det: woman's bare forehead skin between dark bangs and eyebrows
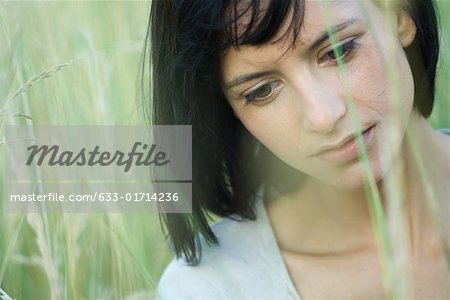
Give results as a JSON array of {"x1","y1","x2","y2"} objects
[{"x1": 220, "y1": 0, "x2": 396, "y2": 84}]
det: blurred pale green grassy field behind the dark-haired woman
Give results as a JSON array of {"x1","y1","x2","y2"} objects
[{"x1": 0, "y1": 0, "x2": 450, "y2": 299}]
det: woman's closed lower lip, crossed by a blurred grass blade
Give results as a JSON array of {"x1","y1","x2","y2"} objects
[{"x1": 316, "y1": 125, "x2": 376, "y2": 163}]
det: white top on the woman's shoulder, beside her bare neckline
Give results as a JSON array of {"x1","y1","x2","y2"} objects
[{"x1": 156, "y1": 193, "x2": 300, "y2": 300}]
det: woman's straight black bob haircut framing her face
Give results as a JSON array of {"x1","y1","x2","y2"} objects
[{"x1": 147, "y1": 0, "x2": 439, "y2": 265}]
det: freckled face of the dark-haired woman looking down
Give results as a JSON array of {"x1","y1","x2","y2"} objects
[{"x1": 221, "y1": 0, "x2": 415, "y2": 189}]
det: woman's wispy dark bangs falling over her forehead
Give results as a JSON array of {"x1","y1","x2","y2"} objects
[{"x1": 222, "y1": 0, "x2": 305, "y2": 49}]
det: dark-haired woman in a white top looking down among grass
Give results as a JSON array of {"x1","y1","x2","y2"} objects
[{"x1": 149, "y1": 0, "x2": 450, "y2": 299}]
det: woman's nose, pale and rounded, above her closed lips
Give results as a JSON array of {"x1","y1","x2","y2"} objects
[{"x1": 300, "y1": 75, "x2": 347, "y2": 134}]
